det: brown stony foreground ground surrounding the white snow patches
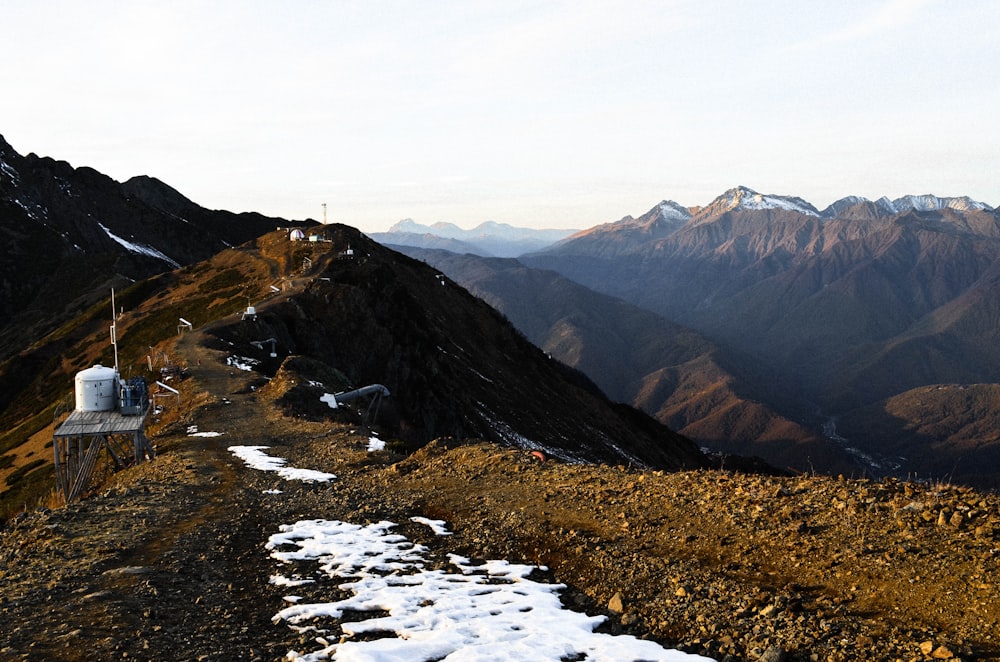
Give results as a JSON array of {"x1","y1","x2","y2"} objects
[{"x1": 0, "y1": 334, "x2": 1000, "y2": 661}]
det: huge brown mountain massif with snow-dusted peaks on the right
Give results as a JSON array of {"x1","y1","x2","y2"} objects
[{"x1": 522, "y1": 189, "x2": 1000, "y2": 482}]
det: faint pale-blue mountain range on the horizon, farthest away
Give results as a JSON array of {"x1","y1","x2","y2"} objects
[{"x1": 369, "y1": 219, "x2": 576, "y2": 257}]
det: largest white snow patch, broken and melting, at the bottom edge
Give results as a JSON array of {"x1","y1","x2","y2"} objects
[{"x1": 266, "y1": 519, "x2": 709, "y2": 662}]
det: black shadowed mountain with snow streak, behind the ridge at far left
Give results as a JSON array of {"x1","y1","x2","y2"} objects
[{"x1": 0, "y1": 137, "x2": 310, "y2": 358}]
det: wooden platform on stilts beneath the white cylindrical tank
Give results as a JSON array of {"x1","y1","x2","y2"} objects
[{"x1": 53, "y1": 408, "x2": 155, "y2": 503}]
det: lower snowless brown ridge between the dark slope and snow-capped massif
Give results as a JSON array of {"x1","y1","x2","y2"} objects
[{"x1": 390, "y1": 246, "x2": 862, "y2": 473}]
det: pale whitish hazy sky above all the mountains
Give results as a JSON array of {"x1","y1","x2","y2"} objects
[{"x1": 0, "y1": 0, "x2": 1000, "y2": 231}]
